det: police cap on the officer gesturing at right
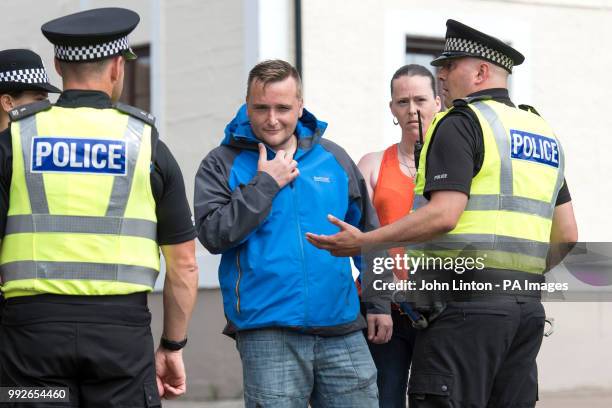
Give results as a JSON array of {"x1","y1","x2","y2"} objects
[{"x1": 431, "y1": 19, "x2": 525, "y2": 73}]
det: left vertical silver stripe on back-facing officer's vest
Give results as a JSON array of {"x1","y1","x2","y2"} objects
[{"x1": 19, "y1": 115, "x2": 49, "y2": 214}]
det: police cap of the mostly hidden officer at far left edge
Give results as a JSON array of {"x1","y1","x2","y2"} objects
[{"x1": 0, "y1": 49, "x2": 61, "y2": 93}]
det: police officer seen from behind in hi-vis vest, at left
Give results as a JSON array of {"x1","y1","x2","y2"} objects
[{"x1": 0, "y1": 8, "x2": 198, "y2": 407}]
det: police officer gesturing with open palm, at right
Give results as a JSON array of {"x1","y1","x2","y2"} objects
[{"x1": 308, "y1": 20, "x2": 578, "y2": 408}]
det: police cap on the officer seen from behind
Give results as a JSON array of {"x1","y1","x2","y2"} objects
[{"x1": 41, "y1": 7, "x2": 140, "y2": 62}]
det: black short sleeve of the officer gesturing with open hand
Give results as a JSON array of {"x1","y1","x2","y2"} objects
[{"x1": 423, "y1": 111, "x2": 483, "y2": 200}]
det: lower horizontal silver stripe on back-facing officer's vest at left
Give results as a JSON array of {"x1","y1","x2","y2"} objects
[{"x1": 2, "y1": 261, "x2": 157, "y2": 287}]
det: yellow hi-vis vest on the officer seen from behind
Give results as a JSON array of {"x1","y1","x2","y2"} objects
[{"x1": 0, "y1": 103, "x2": 159, "y2": 298}]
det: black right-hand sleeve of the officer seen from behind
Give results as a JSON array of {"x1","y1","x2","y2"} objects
[{"x1": 151, "y1": 140, "x2": 196, "y2": 245}]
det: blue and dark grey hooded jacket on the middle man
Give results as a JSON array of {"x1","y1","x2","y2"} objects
[{"x1": 194, "y1": 106, "x2": 388, "y2": 335}]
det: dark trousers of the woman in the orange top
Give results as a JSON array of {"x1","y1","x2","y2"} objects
[{"x1": 368, "y1": 310, "x2": 417, "y2": 408}]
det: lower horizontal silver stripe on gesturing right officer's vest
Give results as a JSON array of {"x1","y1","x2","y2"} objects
[{"x1": 408, "y1": 234, "x2": 548, "y2": 258}]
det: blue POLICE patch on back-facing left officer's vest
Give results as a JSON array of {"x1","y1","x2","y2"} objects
[{"x1": 30, "y1": 137, "x2": 127, "y2": 175}]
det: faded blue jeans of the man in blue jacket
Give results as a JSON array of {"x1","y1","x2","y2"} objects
[{"x1": 236, "y1": 328, "x2": 378, "y2": 408}]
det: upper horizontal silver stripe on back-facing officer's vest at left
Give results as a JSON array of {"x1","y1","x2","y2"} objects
[{"x1": 5, "y1": 214, "x2": 157, "y2": 241}]
